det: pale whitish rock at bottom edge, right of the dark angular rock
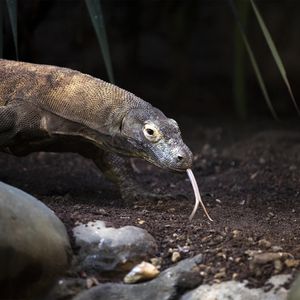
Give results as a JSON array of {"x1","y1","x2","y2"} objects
[{"x1": 180, "y1": 275, "x2": 290, "y2": 300}]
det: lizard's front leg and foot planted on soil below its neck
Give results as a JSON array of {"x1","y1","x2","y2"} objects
[{"x1": 92, "y1": 150, "x2": 171, "y2": 201}]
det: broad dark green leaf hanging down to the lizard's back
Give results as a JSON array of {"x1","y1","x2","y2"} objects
[{"x1": 85, "y1": 0, "x2": 114, "y2": 83}]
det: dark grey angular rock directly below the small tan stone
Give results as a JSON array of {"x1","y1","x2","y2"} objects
[{"x1": 74, "y1": 254, "x2": 202, "y2": 300}]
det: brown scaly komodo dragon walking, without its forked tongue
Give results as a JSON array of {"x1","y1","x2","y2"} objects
[{"x1": 0, "y1": 59, "x2": 192, "y2": 199}]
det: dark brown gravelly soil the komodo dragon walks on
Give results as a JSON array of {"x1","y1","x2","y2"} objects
[{"x1": 0, "y1": 119, "x2": 300, "y2": 288}]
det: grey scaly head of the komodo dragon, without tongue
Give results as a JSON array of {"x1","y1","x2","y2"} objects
[{"x1": 120, "y1": 106, "x2": 193, "y2": 171}]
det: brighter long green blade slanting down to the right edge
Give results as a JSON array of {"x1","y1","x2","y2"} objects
[{"x1": 250, "y1": 0, "x2": 300, "y2": 116}]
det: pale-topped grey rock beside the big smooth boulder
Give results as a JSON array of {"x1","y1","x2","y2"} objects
[{"x1": 73, "y1": 221, "x2": 157, "y2": 274}]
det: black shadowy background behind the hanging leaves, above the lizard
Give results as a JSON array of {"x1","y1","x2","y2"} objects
[{"x1": 2, "y1": 0, "x2": 300, "y2": 118}]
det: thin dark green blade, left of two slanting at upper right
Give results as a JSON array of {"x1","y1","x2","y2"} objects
[{"x1": 228, "y1": 0, "x2": 278, "y2": 120}]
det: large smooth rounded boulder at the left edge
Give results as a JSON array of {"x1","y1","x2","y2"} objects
[{"x1": 0, "y1": 182, "x2": 71, "y2": 299}]
